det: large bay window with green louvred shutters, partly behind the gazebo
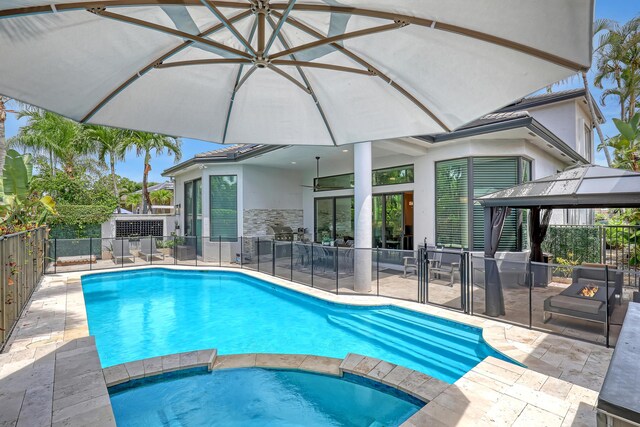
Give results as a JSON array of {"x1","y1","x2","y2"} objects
[{"x1": 436, "y1": 157, "x2": 532, "y2": 251}]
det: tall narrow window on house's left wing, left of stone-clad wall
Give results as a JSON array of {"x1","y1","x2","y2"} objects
[{"x1": 209, "y1": 175, "x2": 238, "y2": 242}]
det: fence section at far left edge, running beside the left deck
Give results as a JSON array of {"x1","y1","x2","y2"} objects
[{"x1": 0, "y1": 227, "x2": 47, "y2": 351}]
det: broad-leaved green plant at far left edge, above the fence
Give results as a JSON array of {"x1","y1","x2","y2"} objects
[{"x1": 0, "y1": 150, "x2": 56, "y2": 233}]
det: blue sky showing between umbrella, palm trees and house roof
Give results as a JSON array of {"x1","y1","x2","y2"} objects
[{"x1": 6, "y1": 0, "x2": 640, "y2": 182}]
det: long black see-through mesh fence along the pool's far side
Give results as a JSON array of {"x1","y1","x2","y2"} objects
[{"x1": 45, "y1": 236, "x2": 624, "y2": 345}]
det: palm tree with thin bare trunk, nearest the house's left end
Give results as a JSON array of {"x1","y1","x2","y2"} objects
[{"x1": 127, "y1": 131, "x2": 182, "y2": 213}]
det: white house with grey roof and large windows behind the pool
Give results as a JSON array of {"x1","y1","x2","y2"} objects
[{"x1": 163, "y1": 90, "x2": 602, "y2": 258}]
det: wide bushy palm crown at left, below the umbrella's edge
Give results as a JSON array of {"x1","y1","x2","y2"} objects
[{"x1": 15, "y1": 108, "x2": 95, "y2": 177}]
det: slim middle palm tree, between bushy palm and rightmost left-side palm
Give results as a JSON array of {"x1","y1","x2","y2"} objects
[{"x1": 86, "y1": 126, "x2": 131, "y2": 213}]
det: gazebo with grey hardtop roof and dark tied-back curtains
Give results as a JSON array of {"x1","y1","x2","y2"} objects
[{"x1": 476, "y1": 165, "x2": 640, "y2": 316}]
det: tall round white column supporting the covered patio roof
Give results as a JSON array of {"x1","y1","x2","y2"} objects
[{"x1": 353, "y1": 142, "x2": 373, "y2": 292}]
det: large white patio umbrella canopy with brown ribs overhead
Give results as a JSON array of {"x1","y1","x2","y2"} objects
[{"x1": 0, "y1": 0, "x2": 593, "y2": 145}]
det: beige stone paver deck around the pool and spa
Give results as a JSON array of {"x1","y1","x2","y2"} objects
[{"x1": 0, "y1": 266, "x2": 612, "y2": 426}]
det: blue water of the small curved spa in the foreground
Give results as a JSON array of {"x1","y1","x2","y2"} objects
[{"x1": 109, "y1": 368, "x2": 423, "y2": 427}]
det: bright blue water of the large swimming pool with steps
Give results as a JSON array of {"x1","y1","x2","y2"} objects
[{"x1": 82, "y1": 268, "x2": 508, "y2": 383}]
